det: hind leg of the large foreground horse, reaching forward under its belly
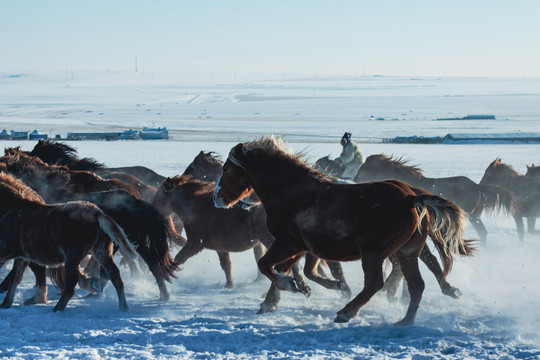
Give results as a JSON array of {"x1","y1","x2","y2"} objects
[{"x1": 334, "y1": 254, "x2": 384, "y2": 323}]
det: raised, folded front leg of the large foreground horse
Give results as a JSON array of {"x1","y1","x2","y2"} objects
[{"x1": 259, "y1": 240, "x2": 310, "y2": 296}]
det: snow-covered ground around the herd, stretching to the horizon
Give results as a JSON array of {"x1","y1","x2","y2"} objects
[{"x1": 0, "y1": 72, "x2": 540, "y2": 359}]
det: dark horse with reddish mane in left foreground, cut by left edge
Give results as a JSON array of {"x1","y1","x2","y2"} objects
[{"x1": 0, "y1": 173, "x2": 135, "y2": 311}]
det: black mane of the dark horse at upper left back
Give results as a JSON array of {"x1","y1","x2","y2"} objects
[{"x1": 29, "y1": 139, "x2": 105, "y2": 171}]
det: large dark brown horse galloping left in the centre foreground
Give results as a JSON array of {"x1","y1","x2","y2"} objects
[{"x1": 214, "y1": 136, "x2": 473, "y2": 325}]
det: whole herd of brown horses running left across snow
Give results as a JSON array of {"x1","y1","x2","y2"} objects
[{"x1": 0, "y1": 136, "x2": 540, "y2": 325}]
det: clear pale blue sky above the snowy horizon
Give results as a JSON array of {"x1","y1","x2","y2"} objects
[{"x1": 0, "y1": 0, "x2": 540, "y2": 76}]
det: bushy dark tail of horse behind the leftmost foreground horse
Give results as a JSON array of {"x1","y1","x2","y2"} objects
[{"x1": 137, "y1": 216, "x2": 178, "y2": 282}]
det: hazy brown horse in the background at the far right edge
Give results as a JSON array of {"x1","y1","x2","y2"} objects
[{"x1": 480, "y1": 158, "x2": 540, "y2": 241}]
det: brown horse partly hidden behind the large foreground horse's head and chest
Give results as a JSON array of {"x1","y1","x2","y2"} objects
[{"x1": 153, "y1": 175, "x2": 273, "y2": 288}]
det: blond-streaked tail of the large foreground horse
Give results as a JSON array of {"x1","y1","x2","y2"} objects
[{"x1": 413, "y1": 195, "x2": 475, "y2": 279}]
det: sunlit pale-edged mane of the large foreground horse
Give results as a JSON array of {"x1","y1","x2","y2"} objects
[{"x1": 229, "y1": 135, "x2": 335, "y2": 181}]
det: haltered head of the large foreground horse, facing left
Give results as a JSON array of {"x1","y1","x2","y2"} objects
[{"x1": 214, "y1": 144, "x2": 253, "y2": 208}]
